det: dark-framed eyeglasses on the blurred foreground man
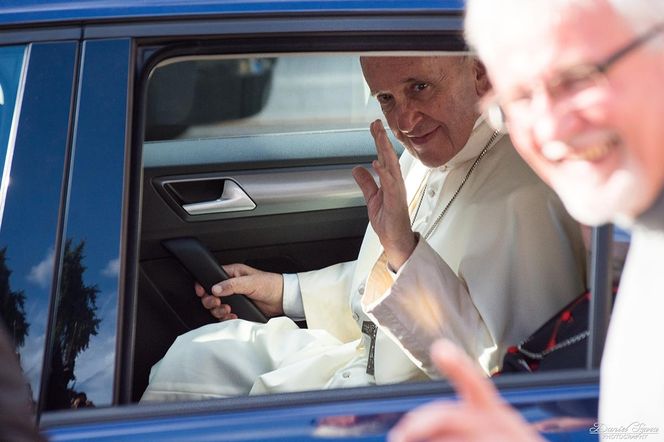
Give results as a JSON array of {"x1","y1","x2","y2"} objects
[{"x1": 483, "y1": 23, "x2": 664, "y2": 132}]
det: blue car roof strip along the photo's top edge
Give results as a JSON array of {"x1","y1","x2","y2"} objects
[{"x1": 0, "y1": 0, "x2": 464, "y2": 26}]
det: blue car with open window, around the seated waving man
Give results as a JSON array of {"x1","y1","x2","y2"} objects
[{"x1": 0, "y1": 0, "x2": 616, "y2": 441}]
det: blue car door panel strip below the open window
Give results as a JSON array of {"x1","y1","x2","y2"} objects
[{"x1": 47, "y1": 383, "x2": 598, "y2": 442}]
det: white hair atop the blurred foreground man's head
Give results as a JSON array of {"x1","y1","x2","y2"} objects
[{"x1": 465, "y1": 0, "x2": 664, "y2": 64}]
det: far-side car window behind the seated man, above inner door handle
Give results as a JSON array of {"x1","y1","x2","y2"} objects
[{"x1": 146, "y1": 55, "x2": 380, "y2": 140}]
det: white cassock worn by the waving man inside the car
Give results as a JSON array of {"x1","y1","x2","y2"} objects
[{"x1": 142, "y1": 121, "x2": 585, "y2": 401}]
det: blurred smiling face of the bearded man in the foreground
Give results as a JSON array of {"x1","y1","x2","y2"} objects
[{"x1": 485, "y1": 2, "x2": 664, "y2": 224}]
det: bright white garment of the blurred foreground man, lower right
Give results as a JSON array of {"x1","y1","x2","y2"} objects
[{"x1": 596, "y1": 192, "x2": 664, "y2": 434}]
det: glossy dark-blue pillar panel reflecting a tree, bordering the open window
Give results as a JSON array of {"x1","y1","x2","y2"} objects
[{"x1": 45, "y1": 40, "x2": 130, "y2": 410}]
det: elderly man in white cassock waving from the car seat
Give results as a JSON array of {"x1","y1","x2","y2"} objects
[{"x1": 142, "y1": 56, "x2": 585, "y2": 401}]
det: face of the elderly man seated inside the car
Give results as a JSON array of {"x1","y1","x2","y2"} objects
[{"x1": 361, "y1": 57, "x2": 488, "y2": 167}]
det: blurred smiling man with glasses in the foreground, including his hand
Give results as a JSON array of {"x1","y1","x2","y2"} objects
[{"x1": 391, "y1": 0, "x2": 664, "y2": 441}]
